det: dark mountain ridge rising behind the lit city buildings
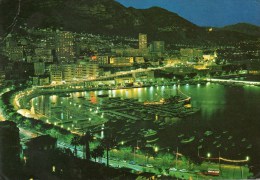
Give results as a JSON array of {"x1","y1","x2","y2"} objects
[{"x1": 0, "y1": 0, "x2": 256, "y2": 44}]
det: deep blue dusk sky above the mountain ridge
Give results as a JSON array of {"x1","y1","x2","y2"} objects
[{"x1": 116, "y1": 0, "x2": 260, "y2": 27}]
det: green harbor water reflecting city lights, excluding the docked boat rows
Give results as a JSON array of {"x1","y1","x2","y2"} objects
[{"x1": 31, "y1": 83, "x2": 260, "y2": 170}]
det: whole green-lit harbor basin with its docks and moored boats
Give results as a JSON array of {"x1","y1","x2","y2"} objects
[{"x1": 28, "y1": 83, "x2": 260, "y2": 167}]
